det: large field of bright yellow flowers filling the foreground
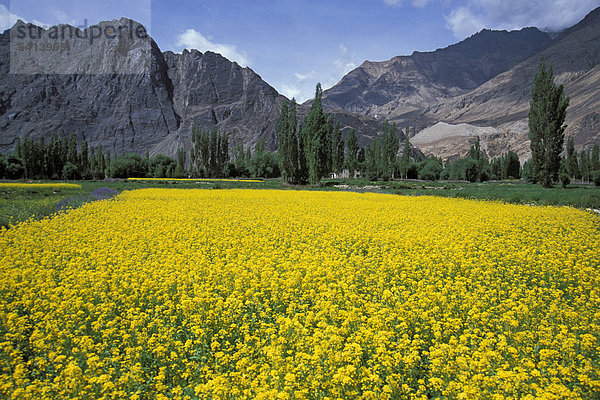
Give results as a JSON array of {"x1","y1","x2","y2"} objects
[{"x1": 0, "y1": 189, "x2": 600, "y2": 399}]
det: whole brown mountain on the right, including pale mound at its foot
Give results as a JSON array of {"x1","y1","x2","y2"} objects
[{"x1": 324, "y1": 8, "x2": 600, "y2": 161}]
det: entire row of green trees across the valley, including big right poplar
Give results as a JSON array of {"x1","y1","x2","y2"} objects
[{"x1": 0, "y1": 74, "x2": 600, "y2": 187}]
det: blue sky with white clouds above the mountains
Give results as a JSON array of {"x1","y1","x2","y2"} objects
[{"x1": 0, "y1": 0, "x2": 600, "y2": 101}]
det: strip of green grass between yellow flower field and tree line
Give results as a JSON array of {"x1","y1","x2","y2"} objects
[{"x1": 0, "y1": 179, "x2": 600, "y2": 227}]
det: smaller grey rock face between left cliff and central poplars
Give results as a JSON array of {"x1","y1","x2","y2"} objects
[{"x1": 153, "y1": 50, "x2": 285, "y2": 154}]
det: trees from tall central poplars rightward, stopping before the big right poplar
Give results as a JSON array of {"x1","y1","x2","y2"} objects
[{"x1": 277, "y1": 85, "x2": 540, "y2": 184}]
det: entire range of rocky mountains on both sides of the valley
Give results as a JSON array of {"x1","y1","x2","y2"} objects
[{"x1": 0, "y1": 9, "x2": 600, "y2": 161}]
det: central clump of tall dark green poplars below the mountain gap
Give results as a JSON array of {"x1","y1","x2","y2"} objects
[{"x1": 277, "y1": 84, "x2": 411, "y2": 185}]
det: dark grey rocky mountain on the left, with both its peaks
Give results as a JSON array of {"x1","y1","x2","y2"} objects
[{"x1": 0, "y1": 18, "x2": 380, "y2": 155}]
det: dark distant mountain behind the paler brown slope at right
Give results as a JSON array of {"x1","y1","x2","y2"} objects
[{"x1": 323, "y1": 28, "x2": 551, "y2": 115}]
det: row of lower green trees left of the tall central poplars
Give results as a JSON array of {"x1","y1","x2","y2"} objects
[{"x1": 0, "y1": 127, "x2": 280, "y2": 180}]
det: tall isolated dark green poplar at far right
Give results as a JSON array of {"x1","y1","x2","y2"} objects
[{"x1": 529, "y1": 59, "x2": 569, "y2": 187}]
